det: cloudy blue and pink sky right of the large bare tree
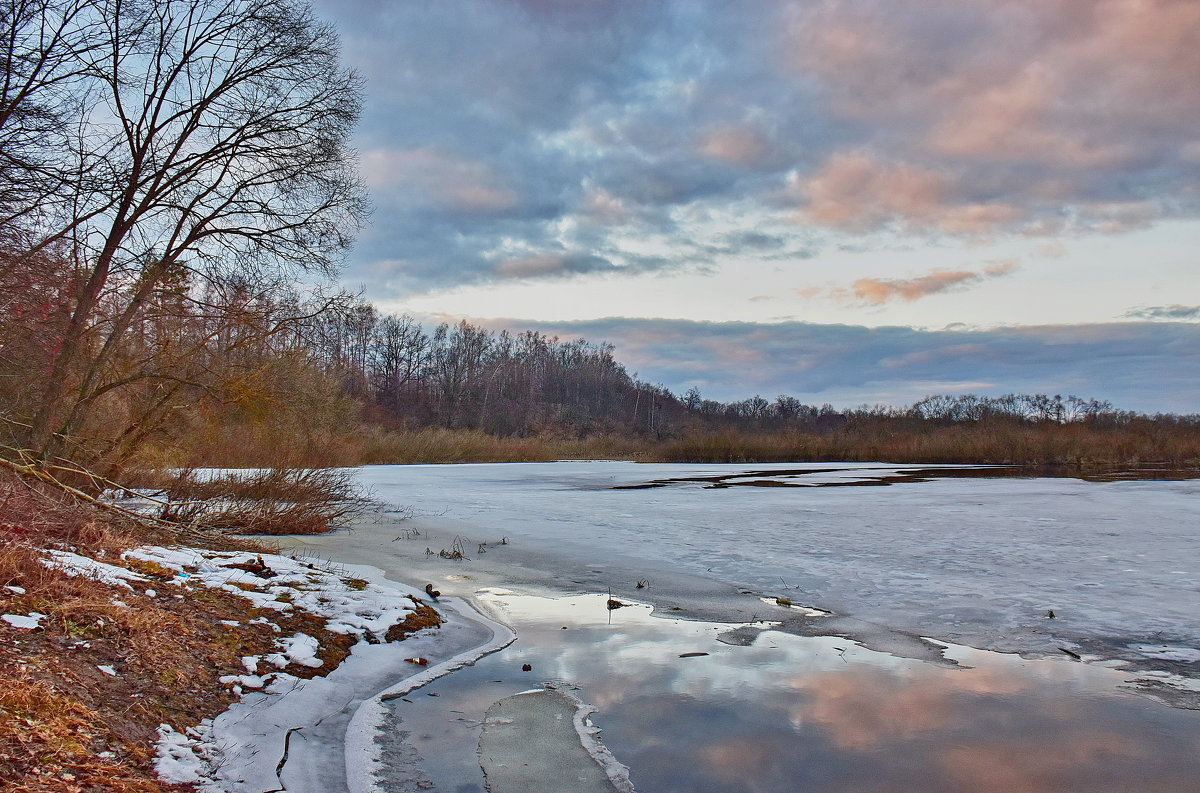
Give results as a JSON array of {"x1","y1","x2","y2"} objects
[{"x1": 316, "y1": 0, "x2": 1200, "y2": 413}]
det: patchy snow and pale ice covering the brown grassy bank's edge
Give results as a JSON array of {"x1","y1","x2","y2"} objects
[{"x1": 120, "y1": 547, "x2": 512, "y2": 793}]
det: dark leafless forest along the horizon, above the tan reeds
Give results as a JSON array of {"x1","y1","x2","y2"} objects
[{"x1": 292, "y1": 297, "x2": 1152, "y2": 439}]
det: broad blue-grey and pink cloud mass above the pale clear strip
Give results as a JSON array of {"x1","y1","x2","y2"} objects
[{"x1": 318, "y1": 0, "x2": 1200, "y2": 295}]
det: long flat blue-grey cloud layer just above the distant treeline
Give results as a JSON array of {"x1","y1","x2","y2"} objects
[{"x1": 468, "y1": 318, "x2": 1200, "y2": 413}]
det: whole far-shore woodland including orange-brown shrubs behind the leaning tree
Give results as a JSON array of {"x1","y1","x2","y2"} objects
[{"x1": 0, "y1": 268, "x2": 1200, "y2": 476}]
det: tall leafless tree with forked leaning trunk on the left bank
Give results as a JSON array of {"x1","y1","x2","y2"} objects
[{"x1": 14, "y1": 0, "x2": 365, "y2": 457}]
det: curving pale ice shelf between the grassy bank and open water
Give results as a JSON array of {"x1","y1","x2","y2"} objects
[{"x1": 144, "y1": 549, "x2": 515, "y2": 793}]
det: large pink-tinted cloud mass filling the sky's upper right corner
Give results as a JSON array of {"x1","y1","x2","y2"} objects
[{"x1": 780, "y1": 0, "x2": 1200, "y2": 235}]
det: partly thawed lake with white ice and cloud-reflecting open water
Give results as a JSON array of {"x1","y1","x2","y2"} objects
[{"x1": 274, "y1": 462, "x2": 1200, "y2": 793}]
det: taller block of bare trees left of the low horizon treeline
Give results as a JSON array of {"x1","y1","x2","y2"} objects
[{"x1": 300, "y1": 302, "x2": 688, "y2": 437}]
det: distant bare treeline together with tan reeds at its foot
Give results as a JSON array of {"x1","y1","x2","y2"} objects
[{"x1": 169, "y1": 295, "x2": 1200, "y2": 465}]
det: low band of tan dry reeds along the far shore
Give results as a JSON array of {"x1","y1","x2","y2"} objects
[{"x1": 162, "y1": 416, "x2": 1200, "y2": 467}]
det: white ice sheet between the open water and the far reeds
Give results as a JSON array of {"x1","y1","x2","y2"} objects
[{"x1": 350, "y1": 462, "x2": 1200, "y2": 659}]
